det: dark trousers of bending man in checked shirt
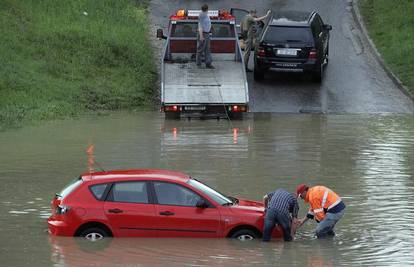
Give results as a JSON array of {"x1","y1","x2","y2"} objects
[{"x1": 263, "y1": 209, "x2": 292, "y2": 242}]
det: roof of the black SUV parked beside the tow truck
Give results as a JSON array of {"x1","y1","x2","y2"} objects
[{"x1": 269, "y1": 10, "x2": 316, "y2": 26}]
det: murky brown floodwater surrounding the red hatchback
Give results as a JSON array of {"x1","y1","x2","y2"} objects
[{"x1": 0, "y1": 112, "x2": 414, "y2": 266}]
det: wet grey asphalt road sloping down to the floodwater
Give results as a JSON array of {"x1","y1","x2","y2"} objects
[{"x1": 151, "y1": 0, "x2": 414, "y2": 114}]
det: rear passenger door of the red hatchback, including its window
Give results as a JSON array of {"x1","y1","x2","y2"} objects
[{"x1": 104, "y1": 181, "x2": 157, "y2": 237}]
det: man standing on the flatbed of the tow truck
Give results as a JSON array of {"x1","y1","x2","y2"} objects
[{"x1": 196, "y1": 4, "x2": 214, "y2": 69}]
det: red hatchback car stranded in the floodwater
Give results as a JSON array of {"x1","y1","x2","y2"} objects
[{"x1": 47, "y1": 169, "x2": 281, "y2": 240}]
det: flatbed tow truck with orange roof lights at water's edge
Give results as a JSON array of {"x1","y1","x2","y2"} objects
[{"x1": 157, "y1": 9, "x2": 249, "y2": 119}]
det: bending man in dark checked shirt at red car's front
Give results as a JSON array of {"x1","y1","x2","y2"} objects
[{"x1": 263, "y1": 189, "x2": 299, "y2": 242}]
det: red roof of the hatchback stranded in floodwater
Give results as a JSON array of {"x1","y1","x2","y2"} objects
[{"x1": 81, "y1": 169, "x2": 190, "y2": 182}]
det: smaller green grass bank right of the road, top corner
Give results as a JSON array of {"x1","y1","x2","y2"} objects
[{"x1": 359, "y1": 0, "x2": 414, "y2": 96}]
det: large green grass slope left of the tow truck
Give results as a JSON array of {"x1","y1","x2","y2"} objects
[{"x1": 0, "y1": 0, "x2": 156, "y2": 130}]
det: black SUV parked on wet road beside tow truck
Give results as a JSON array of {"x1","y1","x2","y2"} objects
[{"x1": 254, "y1": 11, "x2": 332, "y2": 82}]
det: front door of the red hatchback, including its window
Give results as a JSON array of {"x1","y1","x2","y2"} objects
[{"x1": 153, "y1": 181, "x2": 220, "y2": 237}]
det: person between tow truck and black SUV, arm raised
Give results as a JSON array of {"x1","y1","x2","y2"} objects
[{"x1": 240, "y1": 9, "x2": 271, "y2": 72}]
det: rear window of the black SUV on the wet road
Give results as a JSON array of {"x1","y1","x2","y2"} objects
[{"x1": 263, "y1": 26, "x2": 312, "y2": 43}]
